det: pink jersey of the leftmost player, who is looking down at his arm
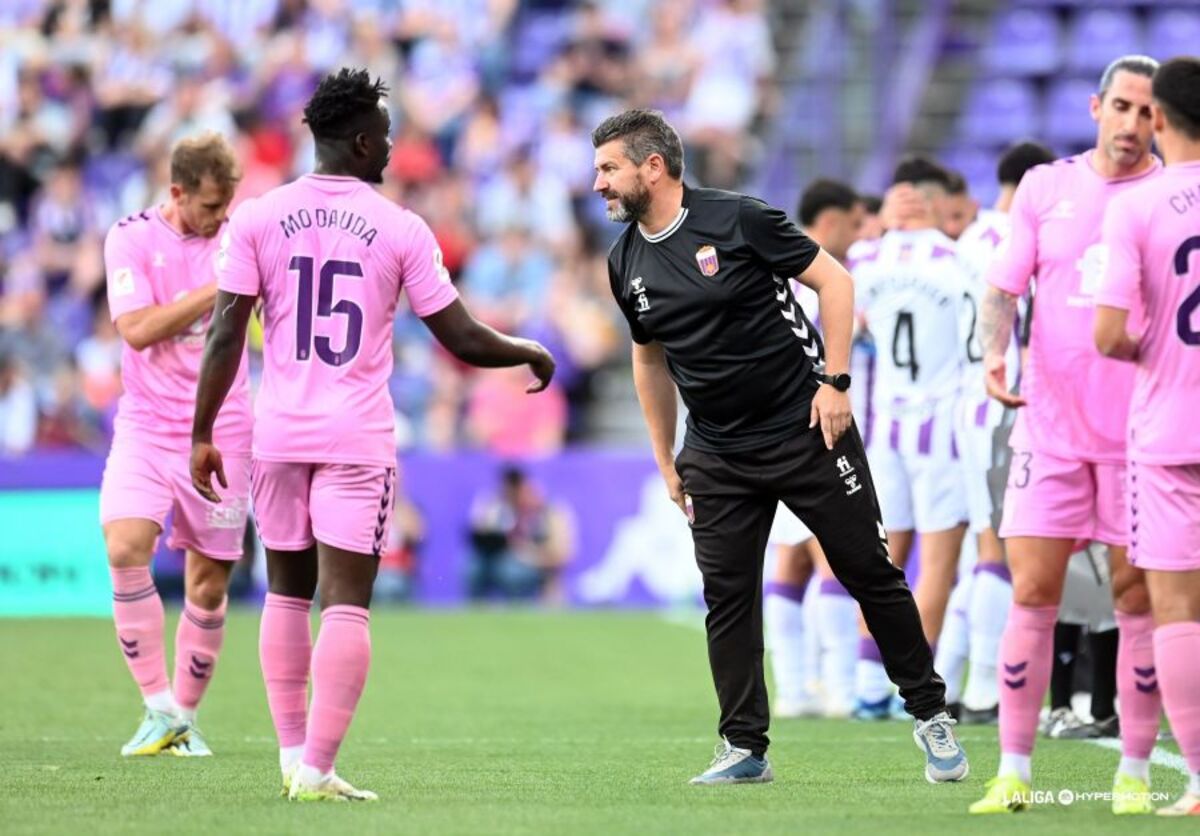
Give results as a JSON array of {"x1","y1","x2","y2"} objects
[{"x1": 104, "y1": 208, "x2": 251, "y2": 455}]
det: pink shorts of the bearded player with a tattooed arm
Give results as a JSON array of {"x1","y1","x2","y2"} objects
[{"x1": 1000, "y1": 449, "x2": 1129, "y2": 546}]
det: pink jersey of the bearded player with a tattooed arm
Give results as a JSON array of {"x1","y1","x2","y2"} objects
[{"x1": 988, "y1": 151, "x2": 1162, "y2": 463}]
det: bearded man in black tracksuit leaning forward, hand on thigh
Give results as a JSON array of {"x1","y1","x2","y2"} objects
[{"x1": 592, "y1": 110, "x2": 967, "y2": 783}]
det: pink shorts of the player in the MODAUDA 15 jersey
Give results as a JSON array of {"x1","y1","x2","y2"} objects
[{"x1": 252, "y1": 459, "x2": 396, "y2": 557}]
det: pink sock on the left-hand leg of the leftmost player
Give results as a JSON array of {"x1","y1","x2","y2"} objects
[{"x1": 108, "y1": 566, "x2": 170, "y2": 708}]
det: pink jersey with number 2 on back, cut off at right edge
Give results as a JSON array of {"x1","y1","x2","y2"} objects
[{"x1": 1096, "y1": 162, "x2": 1200, "y2": 464}]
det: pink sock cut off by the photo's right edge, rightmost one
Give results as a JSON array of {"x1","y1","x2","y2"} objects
[{"x1": 1156, "y1": 621, "x2": 1200, "y2": 776}]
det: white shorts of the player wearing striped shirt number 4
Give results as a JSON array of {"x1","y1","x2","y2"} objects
[{"x1": 866, "y1": 399, "x2": 967, "y2": 534}]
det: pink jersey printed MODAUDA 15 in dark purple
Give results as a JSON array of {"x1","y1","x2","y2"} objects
[{"x1": 218, "y1": 174, "x2": 458, "y2": 467}]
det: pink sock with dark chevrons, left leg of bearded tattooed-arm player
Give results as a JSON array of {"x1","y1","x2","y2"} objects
[{"x1": 998, "y1": 603, "x2": 1058, "y2": 756}]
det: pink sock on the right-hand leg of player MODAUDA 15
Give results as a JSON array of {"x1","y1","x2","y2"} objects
[{"x1": 301, "y1": 606, "x2": 371, "y2": 774}]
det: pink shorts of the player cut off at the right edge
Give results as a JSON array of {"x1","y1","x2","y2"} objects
[{"x1": 1129, "y1": 462, "x2": 1200, "y2": 572}]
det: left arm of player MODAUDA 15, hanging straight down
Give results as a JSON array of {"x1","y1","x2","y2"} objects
[{"x1": 192, "y1": 290, "x2": 256, "y2": 503}]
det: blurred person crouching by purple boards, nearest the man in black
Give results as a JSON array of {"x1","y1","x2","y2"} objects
[{"x1": 468, "y1": 465, "x2": 575, "y2": 603}]
